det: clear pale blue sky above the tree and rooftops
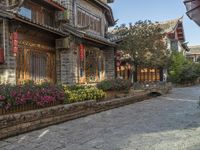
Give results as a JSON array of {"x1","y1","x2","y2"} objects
[{"x1": 110, "y1": 0, "x2": 200, "y2": 46}]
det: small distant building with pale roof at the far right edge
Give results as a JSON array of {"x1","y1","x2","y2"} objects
[{"x1": 186, "y1": 45, "x2": 200, "y2": 62}]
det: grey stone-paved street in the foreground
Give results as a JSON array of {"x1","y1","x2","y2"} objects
[{"x1": 0, "y1": 86, "x2": 200, "y2": 150}]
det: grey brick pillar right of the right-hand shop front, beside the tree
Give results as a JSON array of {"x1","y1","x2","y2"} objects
[{"x1": 104, "y1": 49, "x2": 115, "y2": 79}]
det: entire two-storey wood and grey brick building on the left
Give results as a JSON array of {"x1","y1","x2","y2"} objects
[{"x1": 0, "y1": 0, "x2": 115, "y2": 84}]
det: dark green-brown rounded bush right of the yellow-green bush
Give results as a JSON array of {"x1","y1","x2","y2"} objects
[{"x1": 97, "y1": 79, "x2": 132, "y2": 91}]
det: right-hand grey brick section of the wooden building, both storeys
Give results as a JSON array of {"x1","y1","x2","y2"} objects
[{"x1": 57, "y1": 0, "x2": 116, "y2": 84}]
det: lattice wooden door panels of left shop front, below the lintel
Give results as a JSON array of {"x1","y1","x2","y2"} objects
[{"x1": 16, "y1": 48, "x2": 55, "y2": 82}]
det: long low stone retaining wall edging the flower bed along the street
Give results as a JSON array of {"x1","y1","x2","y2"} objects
[{"x1": 0, "y1": 93, "x2": 148, "y2": 139}]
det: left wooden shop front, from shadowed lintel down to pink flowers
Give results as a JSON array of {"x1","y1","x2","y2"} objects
[{"x1": 15, "y1": 29, "x2": 56, "y2": 83}]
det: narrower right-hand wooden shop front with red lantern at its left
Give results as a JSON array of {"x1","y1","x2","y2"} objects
[{"x1": 79, "y1": 44, "x2": 105, "y2": 84}]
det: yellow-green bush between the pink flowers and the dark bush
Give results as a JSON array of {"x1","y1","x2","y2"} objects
[{"x1": 64, "y1": 85, "x2": 106, "y2": 103}]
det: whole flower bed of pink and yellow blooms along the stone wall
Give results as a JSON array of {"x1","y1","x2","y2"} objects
[{"x1": 0, "y1": 81, "x2": 106, "y2": 115}]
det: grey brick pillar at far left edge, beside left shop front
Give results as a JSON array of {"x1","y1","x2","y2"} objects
[{"x1": 0, "y1": 19, "x2": 16, "y2": 84}]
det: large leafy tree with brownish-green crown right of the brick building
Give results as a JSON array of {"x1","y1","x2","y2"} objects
[{"x1": 115, "y1": 20, "x2": 169, "y2": 67}]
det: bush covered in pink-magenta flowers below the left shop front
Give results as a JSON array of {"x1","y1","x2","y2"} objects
[{"x1": 0, "y1": 81, "x2": 66, "y2": 109}]
